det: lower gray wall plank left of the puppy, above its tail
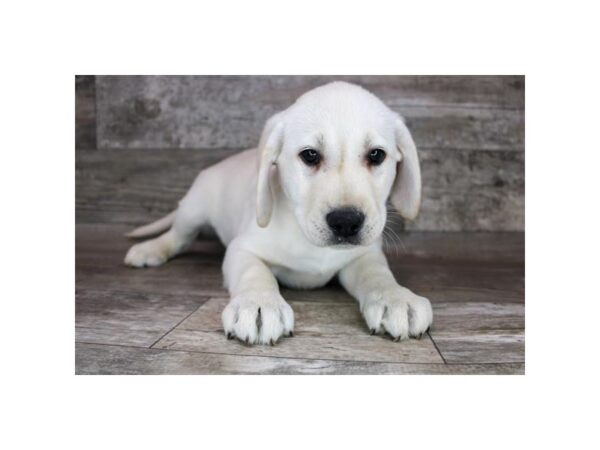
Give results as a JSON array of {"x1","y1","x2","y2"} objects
[{"x1": 75, "y1": 149, "x2": 235, "y2": 225}]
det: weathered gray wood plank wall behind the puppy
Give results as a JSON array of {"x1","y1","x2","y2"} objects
[{"x1": 76, "y1": 76, "x2": 525, "y2": 231}]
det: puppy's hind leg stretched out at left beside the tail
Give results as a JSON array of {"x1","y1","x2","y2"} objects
[{"x1": 125, "y1": 188, "x2": 207, "y2": 267}]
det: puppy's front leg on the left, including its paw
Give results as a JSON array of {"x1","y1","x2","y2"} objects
[{"x1": 222, "y1": 244, "x2": 294, "y2": 344}]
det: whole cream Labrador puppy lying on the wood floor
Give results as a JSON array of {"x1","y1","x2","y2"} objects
[{"x1": 125, "y1": 82, "x2": 433, "y2": 344}]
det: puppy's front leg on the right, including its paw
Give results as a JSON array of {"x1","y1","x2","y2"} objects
[{"x1": 339, "y1": 248, "x2": 433, "y2": 340}]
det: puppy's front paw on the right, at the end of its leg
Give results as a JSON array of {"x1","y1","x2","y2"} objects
[{"x1": 361, "y1": 287, "x2": 433, "y2": 341}]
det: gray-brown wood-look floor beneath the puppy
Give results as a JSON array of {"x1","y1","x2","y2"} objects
[{"x1": 76, "y1": 224, "x2": 525, "y2": 374}]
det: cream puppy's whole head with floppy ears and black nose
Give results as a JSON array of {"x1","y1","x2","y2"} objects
[{"x1": 257, "y1": 82, "x2": 421, "y2": 246}]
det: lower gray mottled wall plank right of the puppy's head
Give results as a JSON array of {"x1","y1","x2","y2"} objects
[{"x1": 406, "y1": 150, "x2": 525, "y2": 231}]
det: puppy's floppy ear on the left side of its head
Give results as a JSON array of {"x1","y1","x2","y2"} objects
[{"x1": 256, "y1": 112, "x2": 283, "y2": 228}]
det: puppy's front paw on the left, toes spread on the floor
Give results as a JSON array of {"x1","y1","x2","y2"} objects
[{"x1": 222, "y1": 291, "x2": 294, "y2": 345}]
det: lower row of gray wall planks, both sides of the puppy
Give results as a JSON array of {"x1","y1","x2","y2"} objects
[{"x1": 76, "y1": 149, "x2": 525, "y2": 231}]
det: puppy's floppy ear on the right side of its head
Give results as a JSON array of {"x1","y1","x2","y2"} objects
[{"x1": 390, "y1": 117, "x2": 421, "y2": 220}]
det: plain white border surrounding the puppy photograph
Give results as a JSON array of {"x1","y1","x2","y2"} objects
[{"x1": 0, "y1": 0, "x2": 599, "y2": 449}]
